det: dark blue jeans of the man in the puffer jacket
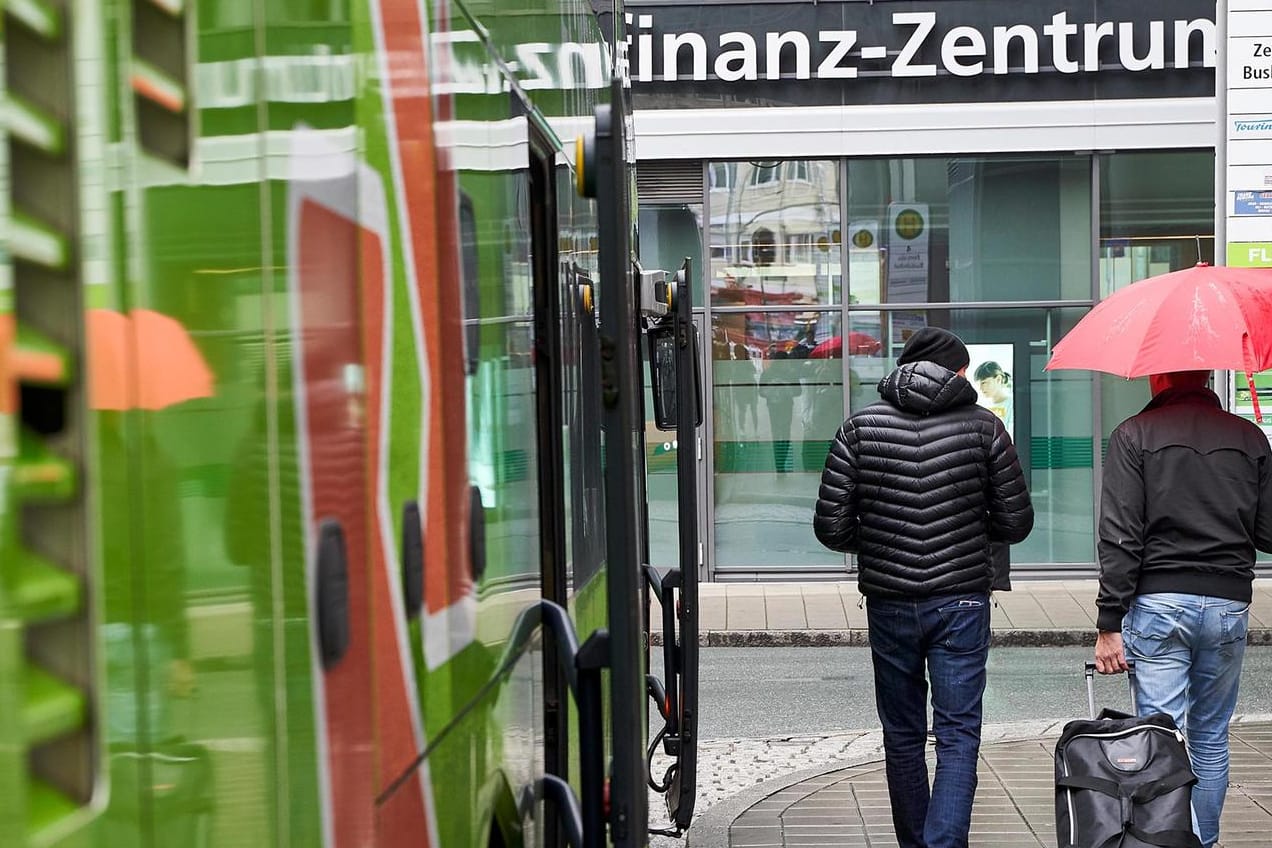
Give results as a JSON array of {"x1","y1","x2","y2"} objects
[{"x1": 866, "y1": 594, "x2": 990, "y2": 848}]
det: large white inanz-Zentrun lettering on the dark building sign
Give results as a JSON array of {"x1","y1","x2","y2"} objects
[{"x1": 627, "y1": 11, "x2": 1216, "y2": 83}]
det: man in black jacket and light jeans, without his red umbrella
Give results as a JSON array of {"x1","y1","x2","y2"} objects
[{"x1": 1095, "y1": 371, "x2": 1272, "y2": 848}]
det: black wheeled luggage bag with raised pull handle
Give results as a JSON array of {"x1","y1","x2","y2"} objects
[{"x1": 1056, "y1": 662, "x2": 1202, "y2": 848}]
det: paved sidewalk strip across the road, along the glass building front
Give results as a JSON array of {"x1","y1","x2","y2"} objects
[{"x1": 661, "y1": 577, "x2": 1272, "y2": 647}]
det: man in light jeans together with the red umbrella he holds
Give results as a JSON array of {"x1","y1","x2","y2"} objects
[{"x1": 1047, "y1": 263, "x2": 1272, "y2": 848}]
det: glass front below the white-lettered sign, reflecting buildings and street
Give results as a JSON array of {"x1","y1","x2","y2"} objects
[{"x1": 641, "y1": 136, "x2": 1216, "y2": 577}]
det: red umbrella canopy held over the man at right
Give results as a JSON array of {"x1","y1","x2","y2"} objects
[{"x1": 1047, "y1": 263, "x2": 1272, "y2": 378}]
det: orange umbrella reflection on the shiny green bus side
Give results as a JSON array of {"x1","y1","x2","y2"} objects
[{"x1": 86, "y1": 309, "x2": 214, "y2": 409}]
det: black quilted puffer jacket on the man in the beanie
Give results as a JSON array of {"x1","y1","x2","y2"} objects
[{"x1": 813, "y1": 362, "x2": 1033, "y2": 598}]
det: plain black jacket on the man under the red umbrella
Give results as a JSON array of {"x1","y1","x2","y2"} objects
[{"x1": 1096, "y1": 389, "x2": 1272, "y2": 631}]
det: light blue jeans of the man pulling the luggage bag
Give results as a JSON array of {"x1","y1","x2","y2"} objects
[{"x1": 1122, "y1": 592, "x2": 1250, "y2": 847}]
